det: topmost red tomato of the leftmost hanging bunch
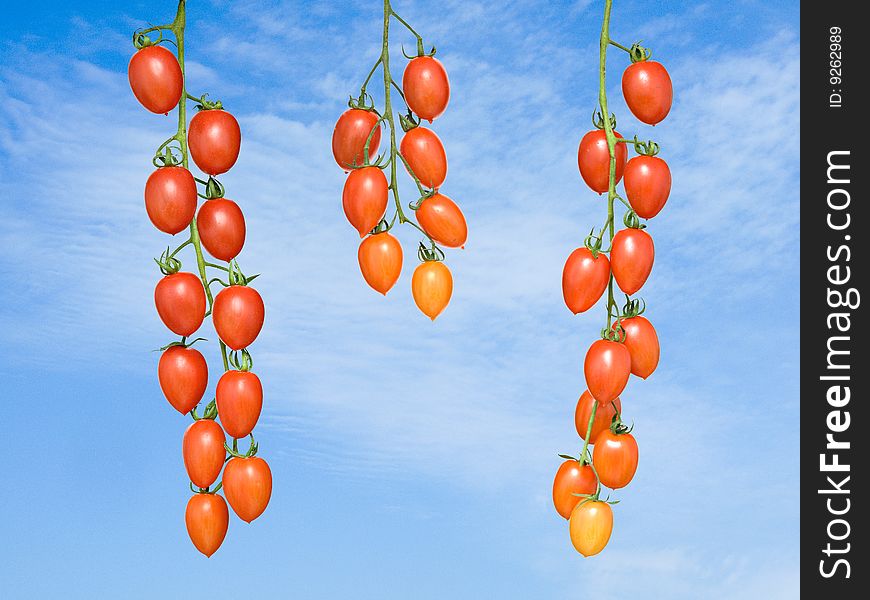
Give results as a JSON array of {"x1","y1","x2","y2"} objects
[{"x1": 127, "y1": 46, "x2": 184, "y2": 114}]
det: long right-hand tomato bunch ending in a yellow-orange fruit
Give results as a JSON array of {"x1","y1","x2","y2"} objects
[{"x1": 553, "y1": 0, "x2": 673, "y2": 556}]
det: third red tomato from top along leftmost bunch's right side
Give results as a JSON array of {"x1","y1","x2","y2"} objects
[{"x1": 212, "y1": 285, "x2": 266, "y2": 350}]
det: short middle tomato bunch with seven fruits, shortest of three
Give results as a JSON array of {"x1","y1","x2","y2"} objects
[{"x1": 332, "y1": 2, "x2": 468, "y2": 321}]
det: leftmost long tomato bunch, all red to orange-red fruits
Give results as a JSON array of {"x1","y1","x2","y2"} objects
[{"x1": 128, "y1": 0, "x2": 272, "y2": 556}]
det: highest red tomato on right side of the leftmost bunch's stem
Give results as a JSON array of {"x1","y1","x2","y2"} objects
[{"x1": 187, "y1": 109, "x2": 242, "y2": 175}]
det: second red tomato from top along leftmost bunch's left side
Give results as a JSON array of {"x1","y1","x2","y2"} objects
[{"x1": 145, "y1": 167, "x2": 197, "y2": 235}]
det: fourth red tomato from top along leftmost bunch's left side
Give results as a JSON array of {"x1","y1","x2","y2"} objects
[{"x1": 157, "y1": 346, "x2": 208, "y2": 414}]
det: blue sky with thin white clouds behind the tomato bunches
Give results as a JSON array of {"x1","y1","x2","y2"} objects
[{"x1": 0, "y1": 0, "x2": 800, "y2": 599}]
